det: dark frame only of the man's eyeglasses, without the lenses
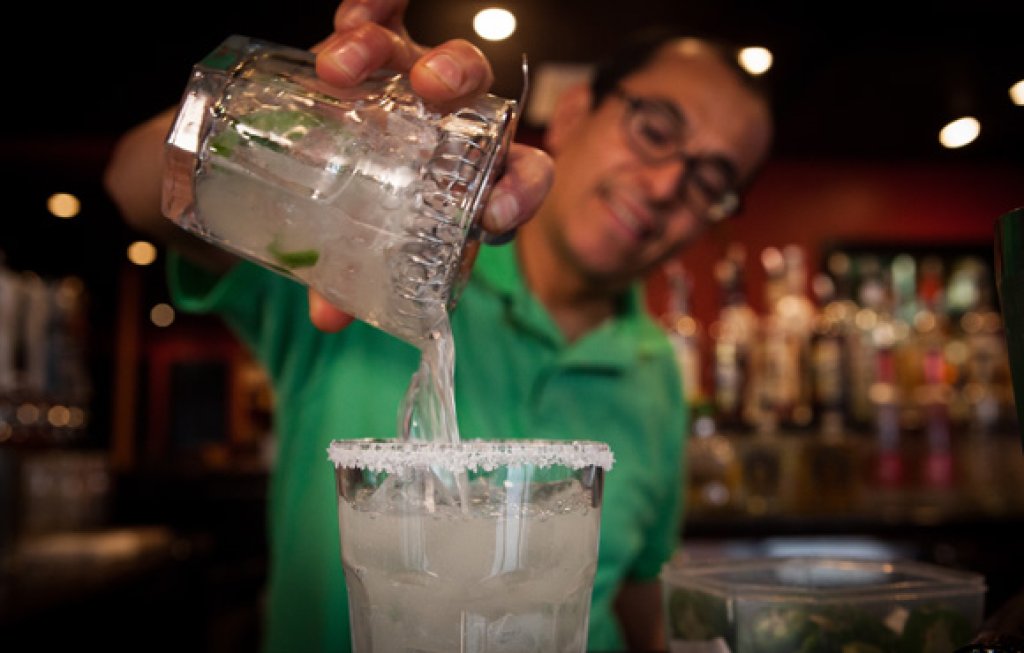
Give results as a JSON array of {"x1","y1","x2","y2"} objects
[{"x1": 610, "y1": 87, "x2": 742, "y2": 223}]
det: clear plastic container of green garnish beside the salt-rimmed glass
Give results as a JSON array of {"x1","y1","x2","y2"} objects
[{"x1": 662, "y1": 557, "x2": 986, "y2": 653}]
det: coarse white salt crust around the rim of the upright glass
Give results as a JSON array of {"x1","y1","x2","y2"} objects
[{"x1": 327, "y1": 439, "x2": 614, "y2": 474}]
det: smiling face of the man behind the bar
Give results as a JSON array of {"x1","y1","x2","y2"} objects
[{"x1": 539, "y1": 44, "x2": 771, "y2": 287}]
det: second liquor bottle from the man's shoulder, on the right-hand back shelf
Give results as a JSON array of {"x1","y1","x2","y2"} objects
[{"x1": 711, "y1": 243, "x2": 758, "y2": 433}]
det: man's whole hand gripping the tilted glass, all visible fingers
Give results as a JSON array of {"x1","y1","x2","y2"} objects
[{"x1": 309, "y1": 0, "x2": 553, "y2": 332}]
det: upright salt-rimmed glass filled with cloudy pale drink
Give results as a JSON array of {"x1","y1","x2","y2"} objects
[{"x1": 328, "y1": 439, "x2": 613, "y2": 653}]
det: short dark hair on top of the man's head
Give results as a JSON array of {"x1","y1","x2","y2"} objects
[{"x1": 590, "y1": 27, "x2": 771, "y2": 106}]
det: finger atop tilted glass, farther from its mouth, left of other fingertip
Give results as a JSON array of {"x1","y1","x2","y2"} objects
[{"x1": 316, "y1": 23, "x2": 425, "y2": 86}]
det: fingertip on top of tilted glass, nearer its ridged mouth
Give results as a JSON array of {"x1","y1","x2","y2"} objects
[{"x1": 410, "y1": 39, "x2": 495, "y2": 103}]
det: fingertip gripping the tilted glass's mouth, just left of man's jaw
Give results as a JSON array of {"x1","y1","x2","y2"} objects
[{"x1": 480, "y1": 143, "x2": 554, "y2": 233}]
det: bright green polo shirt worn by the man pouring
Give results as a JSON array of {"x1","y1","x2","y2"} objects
[{"x1": 169, "y1": 246, "x2": 686, "y2": 652}]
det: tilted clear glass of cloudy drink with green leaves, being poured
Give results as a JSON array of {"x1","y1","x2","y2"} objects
[{"x1": 164, "y1": 36, "x2": 518, "y2": 345}]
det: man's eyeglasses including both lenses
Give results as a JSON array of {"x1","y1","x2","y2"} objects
[{"x1": 612, "y1": 89, "x2": 740, "y2": 222}]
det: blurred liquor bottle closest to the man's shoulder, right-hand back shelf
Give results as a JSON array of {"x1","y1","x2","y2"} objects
[{"x1": 663, "y1": 260, "x2": 703, "y2": 407}]
